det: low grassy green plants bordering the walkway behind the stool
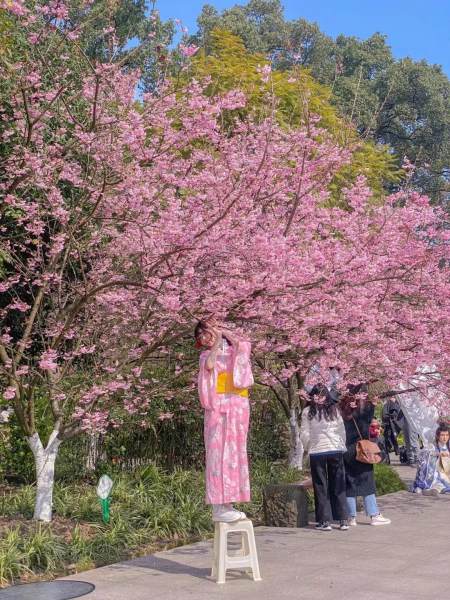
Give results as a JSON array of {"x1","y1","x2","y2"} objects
[{"x1": 0, "y1": 461, "x2": 298, "y2": 586}]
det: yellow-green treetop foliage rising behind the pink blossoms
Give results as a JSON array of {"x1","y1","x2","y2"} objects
[{"x1": 190, "y1": 29, "x2": 402, "y2": 204}]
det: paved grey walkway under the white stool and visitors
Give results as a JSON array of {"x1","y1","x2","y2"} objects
[{"x1": 68, "y1": 466, "x2": 450, "y2": 600}]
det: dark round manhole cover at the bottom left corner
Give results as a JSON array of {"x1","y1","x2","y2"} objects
[{"x1": 0, "y1": 581, "x2": 95, "y2": 600}]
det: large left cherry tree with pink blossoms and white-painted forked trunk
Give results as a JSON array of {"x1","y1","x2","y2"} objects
[{"x1": 0, "y1": 2, "x2": 342, "y2": 520}]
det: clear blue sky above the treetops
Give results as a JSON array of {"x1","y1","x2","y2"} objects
[{"x1": 157, "y1": 0, "x2": 450, "y2": 75}]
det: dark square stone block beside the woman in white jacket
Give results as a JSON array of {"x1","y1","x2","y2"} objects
[{"x1": 264, "y1": 482, "x2": 308, "y2": 527}]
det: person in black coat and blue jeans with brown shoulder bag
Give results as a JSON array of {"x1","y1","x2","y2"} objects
[{"x1": 341, "y1": 384, "x2": 391, "y2": 525}]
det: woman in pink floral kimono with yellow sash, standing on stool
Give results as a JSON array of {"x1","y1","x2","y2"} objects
[{"x1": 195, "y1": 321, "x2": 253, "y2": 522}]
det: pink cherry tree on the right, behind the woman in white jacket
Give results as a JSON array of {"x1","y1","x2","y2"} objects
[{"x1": 250, "y1": 175, "x2": 450, "y2": 467}]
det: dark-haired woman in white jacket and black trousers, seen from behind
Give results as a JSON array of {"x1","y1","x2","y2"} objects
[{"x1": 300, "y1": 389, "x2": 348, "y2": 531}]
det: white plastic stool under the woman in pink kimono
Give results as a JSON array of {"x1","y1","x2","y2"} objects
[{"x1": 211, "y1": 519, "x2": 261, "y2": 583}]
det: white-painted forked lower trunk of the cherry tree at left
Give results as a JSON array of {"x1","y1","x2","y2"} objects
[{"x1": 27, "y1": 430, "x2": 61, "y2": 522}]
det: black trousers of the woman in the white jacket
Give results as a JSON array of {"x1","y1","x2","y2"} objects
[{"x1": 309, "y1": 452, "x2": 348, "y2": 523}]
